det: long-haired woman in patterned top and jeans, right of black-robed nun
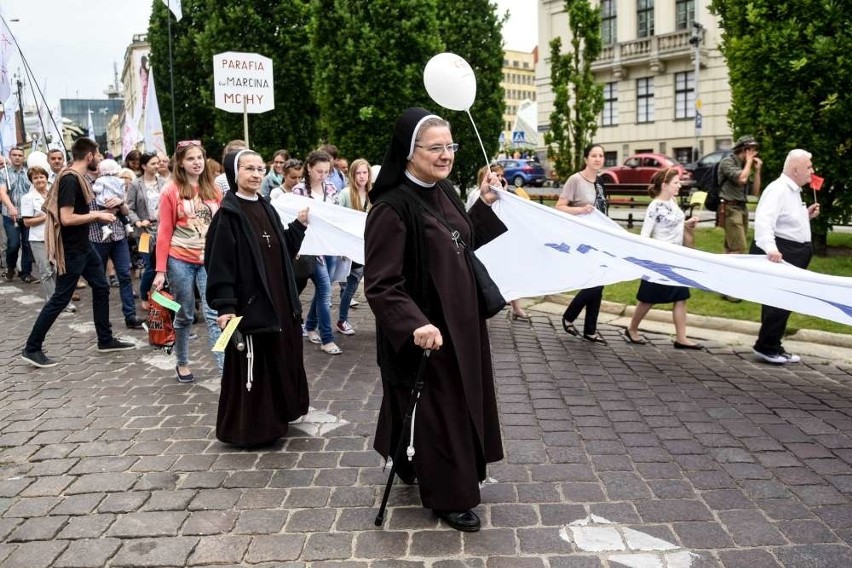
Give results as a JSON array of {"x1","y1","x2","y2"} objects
[{"x1": 293, "y1": 150, "x2": 343, "y2": 355}]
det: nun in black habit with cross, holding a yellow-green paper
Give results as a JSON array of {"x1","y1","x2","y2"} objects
[{"x1": 204, "y1": 150, "x2": 308, "y2": 447}]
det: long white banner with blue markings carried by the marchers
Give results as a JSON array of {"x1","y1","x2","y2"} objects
[{"x1": 266, "y1": 192, "x2": 852, "y2": 325}]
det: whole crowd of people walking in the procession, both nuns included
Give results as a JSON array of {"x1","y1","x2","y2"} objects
[{"x1": 0, "y1": 115, "x2": 819, "y2": 531}]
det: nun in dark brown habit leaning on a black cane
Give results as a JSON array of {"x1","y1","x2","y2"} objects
[{"x1": 364, "y1": 108, "x2": 506, "y2": 531}]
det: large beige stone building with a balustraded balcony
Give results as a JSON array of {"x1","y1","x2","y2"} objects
[{"x1": 536, "y1": 0, "x2": 732, "y2": 170}]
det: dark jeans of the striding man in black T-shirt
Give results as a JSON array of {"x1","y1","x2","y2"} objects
[{"x1": 26, "y1": 245, "x2": 112, "y2": 353}]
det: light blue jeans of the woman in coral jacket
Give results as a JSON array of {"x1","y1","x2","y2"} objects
[{"x1": 167, "y1": 257, "x2": 225, "y2": 372}]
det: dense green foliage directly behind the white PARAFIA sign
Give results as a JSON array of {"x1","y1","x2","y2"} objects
[{"x1": 148, "y1": 0, "x2": 317, "y2": 159}]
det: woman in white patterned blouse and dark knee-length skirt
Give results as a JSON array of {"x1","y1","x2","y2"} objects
[{"x1": 624, "y1": 168, "x2": 702, "y2": 349}]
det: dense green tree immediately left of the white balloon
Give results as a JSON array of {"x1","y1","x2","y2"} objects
[{"x1": 310, "y1": 0, "x2": 441, "y2": 168}]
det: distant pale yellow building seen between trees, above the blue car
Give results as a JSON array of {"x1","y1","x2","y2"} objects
[{"x1": 500, "y1": 50, "x2": 536, "y2": 151}]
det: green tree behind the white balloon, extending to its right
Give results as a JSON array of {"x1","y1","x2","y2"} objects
[{"x1": 440, "y1": 0, "x2": 508, "y2": 195}]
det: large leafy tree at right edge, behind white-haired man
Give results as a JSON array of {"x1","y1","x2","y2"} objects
[{"x1": 710, "y1": 0, "x2": 852, "y2": 253}]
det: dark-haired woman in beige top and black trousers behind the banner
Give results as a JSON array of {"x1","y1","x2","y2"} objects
[{"x1": 556, "y1": 144, "x2": 607, "y2": 345}]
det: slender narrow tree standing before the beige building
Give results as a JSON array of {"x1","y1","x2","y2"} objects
[{"x1": 544, "y1": 0, "x2": 603, "y2": 179}]
